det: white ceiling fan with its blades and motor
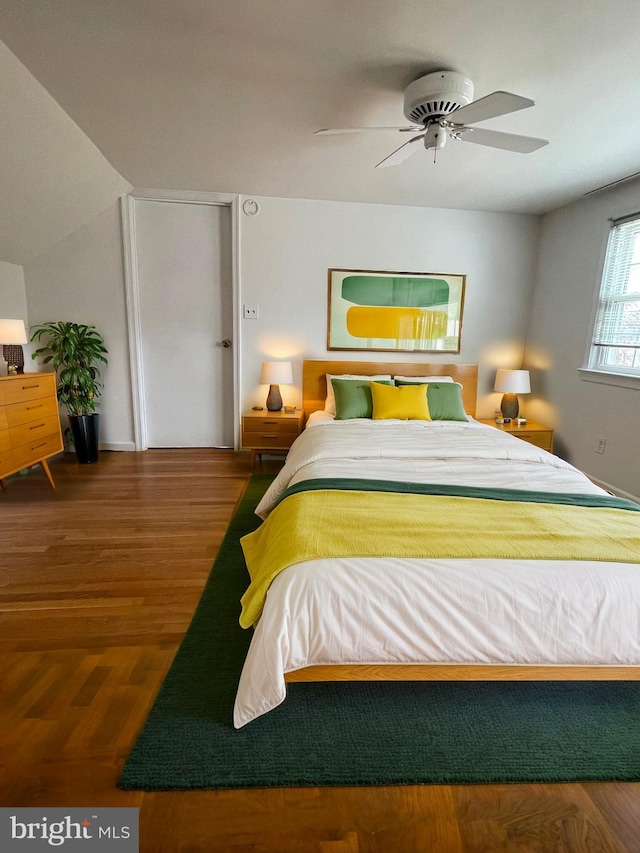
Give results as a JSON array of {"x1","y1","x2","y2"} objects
[{"x1": 315, "y1": 71, "x2": 548, "y2": 169}]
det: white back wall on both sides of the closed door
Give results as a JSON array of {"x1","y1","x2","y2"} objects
[{"x1": 25, "y1": 192, "x2": 539, "y2": 449}]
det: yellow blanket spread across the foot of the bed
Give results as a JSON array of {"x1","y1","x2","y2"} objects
[{"x1": 240, "y1": 490, "x2": 640, "y2": 628}]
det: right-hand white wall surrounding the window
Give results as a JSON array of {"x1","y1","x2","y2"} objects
[{"x1": 526, "y1": 182, "x2": 640, "y2": 496}]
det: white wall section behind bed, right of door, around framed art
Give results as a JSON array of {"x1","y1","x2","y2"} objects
[{"x1": 240, "y1": 198, "x2": 539, "y2": 417}]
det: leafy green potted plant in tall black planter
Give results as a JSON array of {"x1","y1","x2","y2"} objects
[{"x1": 31, "y1": 322, "x2": 107, "y2": 462}]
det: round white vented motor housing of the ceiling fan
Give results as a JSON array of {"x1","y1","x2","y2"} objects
[{"x1": 404, "y1": 71, "x2": 473, "y2": 124}]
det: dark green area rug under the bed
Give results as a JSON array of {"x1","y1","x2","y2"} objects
[{"x1": 119, "y1": 474, "x2": 640, "y2": 790}]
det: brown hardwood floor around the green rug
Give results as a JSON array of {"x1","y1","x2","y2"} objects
[{"x1": 0, "y1": 450, "x2": 640, "y2": 853}]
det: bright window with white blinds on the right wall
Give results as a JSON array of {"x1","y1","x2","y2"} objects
[{"x1": 589, "y1": 214, "x2": 640, "y2": 376}]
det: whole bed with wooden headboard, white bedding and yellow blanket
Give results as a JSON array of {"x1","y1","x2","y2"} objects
[{"x1": 234, "y1": 360, "x2": 640, "y2": 728}]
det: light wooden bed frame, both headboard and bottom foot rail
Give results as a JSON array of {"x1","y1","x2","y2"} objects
[{"x1": 285, "y1": 360, "x2": 640, "y2": 682}]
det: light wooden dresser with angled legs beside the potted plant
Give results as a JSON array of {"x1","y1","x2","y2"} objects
[{"x1": 0, "y1": 373, "x2": 63, "y2": 489}]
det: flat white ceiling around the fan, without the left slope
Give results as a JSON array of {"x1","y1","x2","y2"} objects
[{"x1": 0, "y1": 0, "x2": 640, "y2": 262}]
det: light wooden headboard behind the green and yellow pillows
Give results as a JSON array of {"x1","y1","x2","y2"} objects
[{"x1": 302, "y1": 359, "x2": 478, "y2": 419}]
